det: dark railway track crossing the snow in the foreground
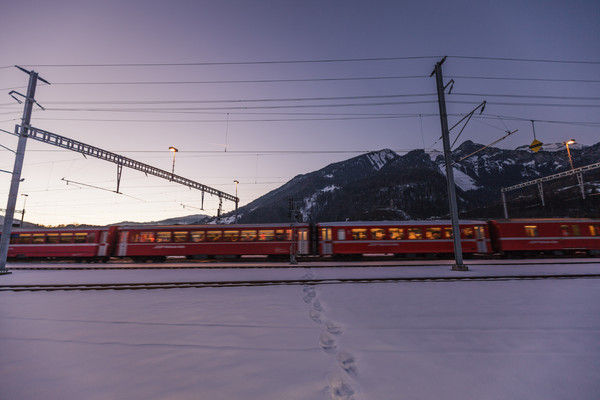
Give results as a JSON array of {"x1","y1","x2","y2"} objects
[{"x1": 0, "y1": 274, "x2": 600, "y2": 292}]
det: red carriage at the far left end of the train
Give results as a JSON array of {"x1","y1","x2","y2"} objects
[{"x1": 8, "y1": 227, "x2": 115, "y2": 262}]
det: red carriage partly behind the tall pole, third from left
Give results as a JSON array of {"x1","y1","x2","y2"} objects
[{"x1": 317, "y1": 221, "x2": 492, "y2": 256}]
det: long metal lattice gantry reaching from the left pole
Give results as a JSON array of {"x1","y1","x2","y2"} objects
[{"x1": 8, "y1": 126, "x2": 239, "y2": 205}]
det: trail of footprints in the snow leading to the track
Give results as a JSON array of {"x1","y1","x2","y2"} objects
[{"x1": 302, "y1": 269, "x2": 358, "y2": 400}]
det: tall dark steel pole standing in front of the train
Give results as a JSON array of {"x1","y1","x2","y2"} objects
[{"x1": 434, "y1": 58, "x2": 469, "y2": 271}]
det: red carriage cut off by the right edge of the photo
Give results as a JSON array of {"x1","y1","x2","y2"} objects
[{"x1": 489, "y1": 218, "x2": 600, "y2": 255}]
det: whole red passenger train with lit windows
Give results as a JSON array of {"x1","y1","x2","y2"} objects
[{"x1": 3, "y1": 219, "x2": 600, "y2": 262}]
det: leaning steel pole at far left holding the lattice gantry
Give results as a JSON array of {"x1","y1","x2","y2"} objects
[{"x1": 0, "y1": 71, "x2": 38, "y2": 273}]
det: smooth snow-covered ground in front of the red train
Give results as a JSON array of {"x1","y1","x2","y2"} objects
[{"x1": 0, "y1": 263, "x2": 600, "y2": 400}]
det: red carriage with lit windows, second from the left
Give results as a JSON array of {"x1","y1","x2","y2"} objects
[{"x1": 115, "y1": 220, "x2": 309, "y2": 261}]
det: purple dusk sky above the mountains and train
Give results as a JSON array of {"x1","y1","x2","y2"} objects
[{"x1": 0, "y1": 0, "x2": 600, "y2": 225}]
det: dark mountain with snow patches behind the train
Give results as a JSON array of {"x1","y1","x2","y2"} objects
[{"x1": 221, "y1": 141, "x2": 600, "y2": 223}]
